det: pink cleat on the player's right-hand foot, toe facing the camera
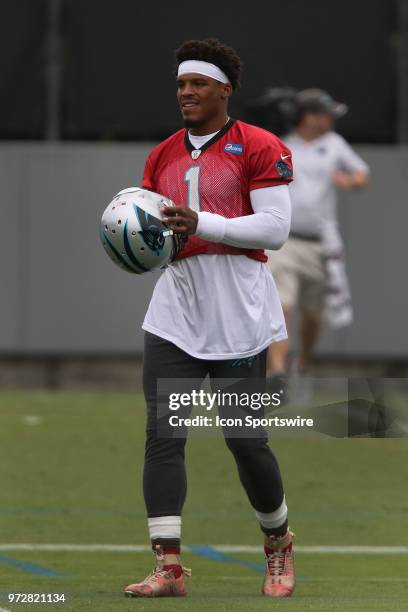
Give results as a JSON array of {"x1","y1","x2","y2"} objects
[{"x1": 262, "y1": 529, "x2": 295, "y2": 597}]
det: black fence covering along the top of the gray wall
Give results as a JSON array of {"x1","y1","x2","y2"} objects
[{"x1": 0, "y1": 0, "x2": 402, "y2": 143}]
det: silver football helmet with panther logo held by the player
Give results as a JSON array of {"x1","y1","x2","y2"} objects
[{"x1": 100, "y1": 187, "x2": 186, "y2": 274}]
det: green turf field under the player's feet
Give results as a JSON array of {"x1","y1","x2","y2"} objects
[{"x1": 0, "y1": 392, "x2": 408, "y2": 612}]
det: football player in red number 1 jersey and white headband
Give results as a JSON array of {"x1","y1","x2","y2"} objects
[{"x1": 125, "y1": 39, "x2": 294, "y2": 597}]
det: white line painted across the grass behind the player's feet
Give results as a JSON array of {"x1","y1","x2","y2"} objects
[{"x1": 0, "y1": 544, "x2": 408, "y2": 555}]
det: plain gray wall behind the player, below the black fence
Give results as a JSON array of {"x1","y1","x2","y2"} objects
[{"x1": 0, "y1": 143, "x2": 408, "y2": 358}]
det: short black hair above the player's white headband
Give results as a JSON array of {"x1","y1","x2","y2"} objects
[{"x1": 176, "y1": 38, "x2": 242, "y2": 89}]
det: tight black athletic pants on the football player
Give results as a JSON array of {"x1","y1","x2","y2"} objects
[{"x1": 143, "y1": 332, "x2": 283, "y2": 517}]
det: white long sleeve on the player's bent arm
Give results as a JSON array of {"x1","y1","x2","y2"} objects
[{"x1": 196, "y1": 185, "x2": 291, "y2": 250}]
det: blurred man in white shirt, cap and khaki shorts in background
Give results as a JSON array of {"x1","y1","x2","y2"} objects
[{"x1": 268, "y1": 89, "x2": 369, "y2": 380}]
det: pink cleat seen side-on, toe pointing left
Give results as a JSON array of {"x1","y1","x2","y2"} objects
[{"x1": 125, "y1": 545, "x2": 191, "y2": 597}]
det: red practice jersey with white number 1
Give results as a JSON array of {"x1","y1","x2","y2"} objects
[{"x1": 143, "y1": 119, "x2": 292, "y2": 261}]
